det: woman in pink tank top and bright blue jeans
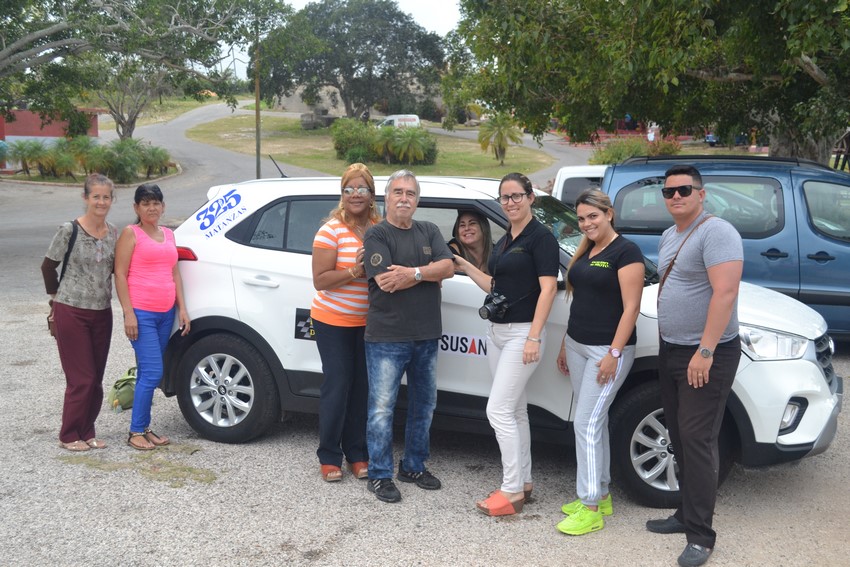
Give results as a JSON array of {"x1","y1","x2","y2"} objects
[{"x1": 115, "y1": 183, "x2": 191, "y2": 451}]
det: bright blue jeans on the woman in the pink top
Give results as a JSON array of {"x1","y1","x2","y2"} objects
[{"x1": 130, "y1": 307, "x2": 175, "y2": 433}]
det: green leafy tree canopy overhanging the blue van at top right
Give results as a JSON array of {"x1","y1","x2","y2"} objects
[{"x1": 459, "y1": 0, "x2": 850, "y2": 162}]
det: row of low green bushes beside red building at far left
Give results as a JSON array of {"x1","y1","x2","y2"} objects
[{"x1": 8, "y1": 136, "x2": 171, "y2": 183}]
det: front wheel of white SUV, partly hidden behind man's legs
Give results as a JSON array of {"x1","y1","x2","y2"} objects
[{"x1": 610, "y1": 381, "x2": 734, "y2": 508}]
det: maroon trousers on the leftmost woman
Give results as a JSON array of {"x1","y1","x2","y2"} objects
[{"x1": 53, "y1": 302, "x2": 112, "y2": 443}]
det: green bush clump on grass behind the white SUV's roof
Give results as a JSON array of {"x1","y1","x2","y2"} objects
[{"x1": 331, "y1": 118, "x2": 437, "y2": 165}]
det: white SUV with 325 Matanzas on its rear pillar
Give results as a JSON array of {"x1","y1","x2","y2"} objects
[{"x1": 162, "y1": 177, "x2": 843, "y2": 506}]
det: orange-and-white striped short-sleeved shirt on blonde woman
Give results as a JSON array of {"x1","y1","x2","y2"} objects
[{"x1": 310, "y1": 219, "x2": 369, "y2": 327}]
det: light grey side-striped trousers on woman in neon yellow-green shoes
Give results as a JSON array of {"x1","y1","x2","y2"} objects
[{"x1": 564, "y1": 335, "x2": 635, "y2": 506}]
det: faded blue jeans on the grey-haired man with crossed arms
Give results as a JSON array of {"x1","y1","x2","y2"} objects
[{"x1": 366, "y1": 339, "x2": 438, "y2": 479}]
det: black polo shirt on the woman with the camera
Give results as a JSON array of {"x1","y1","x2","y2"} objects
[{"x1": 488, "y1": 218, "x2": 560, "y2": 323}]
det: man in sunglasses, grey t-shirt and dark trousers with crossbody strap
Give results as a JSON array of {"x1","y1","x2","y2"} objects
[{"x1": 646, "y1": 165, "x2": 744, "y2": 567}]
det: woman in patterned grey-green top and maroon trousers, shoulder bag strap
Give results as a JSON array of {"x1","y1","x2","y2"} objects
[{"x1": 41, "y1": 173, "x2": 118, "y2": 451}]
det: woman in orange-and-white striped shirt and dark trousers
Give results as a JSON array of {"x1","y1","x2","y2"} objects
[{"x1": 310, "y1": 163, "x2": 380, "y2": 482}]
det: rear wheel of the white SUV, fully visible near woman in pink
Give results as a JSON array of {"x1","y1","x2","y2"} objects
[{"x1": 176, "y1": 334, "x2": 280, "y2": 443}]
